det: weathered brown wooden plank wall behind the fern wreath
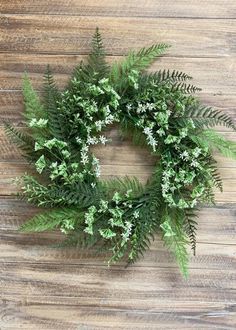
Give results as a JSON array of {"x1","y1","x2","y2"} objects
[{"x1": 0, "y1": 0, "x2": 236, "y2": 330}]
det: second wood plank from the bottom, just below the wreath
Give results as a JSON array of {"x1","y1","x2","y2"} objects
[{"x1": 0, "y1": 262, "x2": 236, "y2": 312}]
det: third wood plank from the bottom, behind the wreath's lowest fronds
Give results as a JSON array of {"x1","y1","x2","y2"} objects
[{"x1": 0, "y1": 227, "x2": 236, "y2": 273}]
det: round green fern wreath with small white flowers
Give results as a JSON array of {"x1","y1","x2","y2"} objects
[{"x1": 5, "y1": 29, "x2": 236, "y2": 276}]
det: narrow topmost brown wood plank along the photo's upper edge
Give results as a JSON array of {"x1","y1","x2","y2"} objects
[{"x1": 0, "y1": 0, "x2": 236, "y2": 18}]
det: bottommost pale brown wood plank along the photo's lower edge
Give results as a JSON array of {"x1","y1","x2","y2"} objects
[{"x1": 2, "y1": 286, "x2": 235, "y2": 330}]
